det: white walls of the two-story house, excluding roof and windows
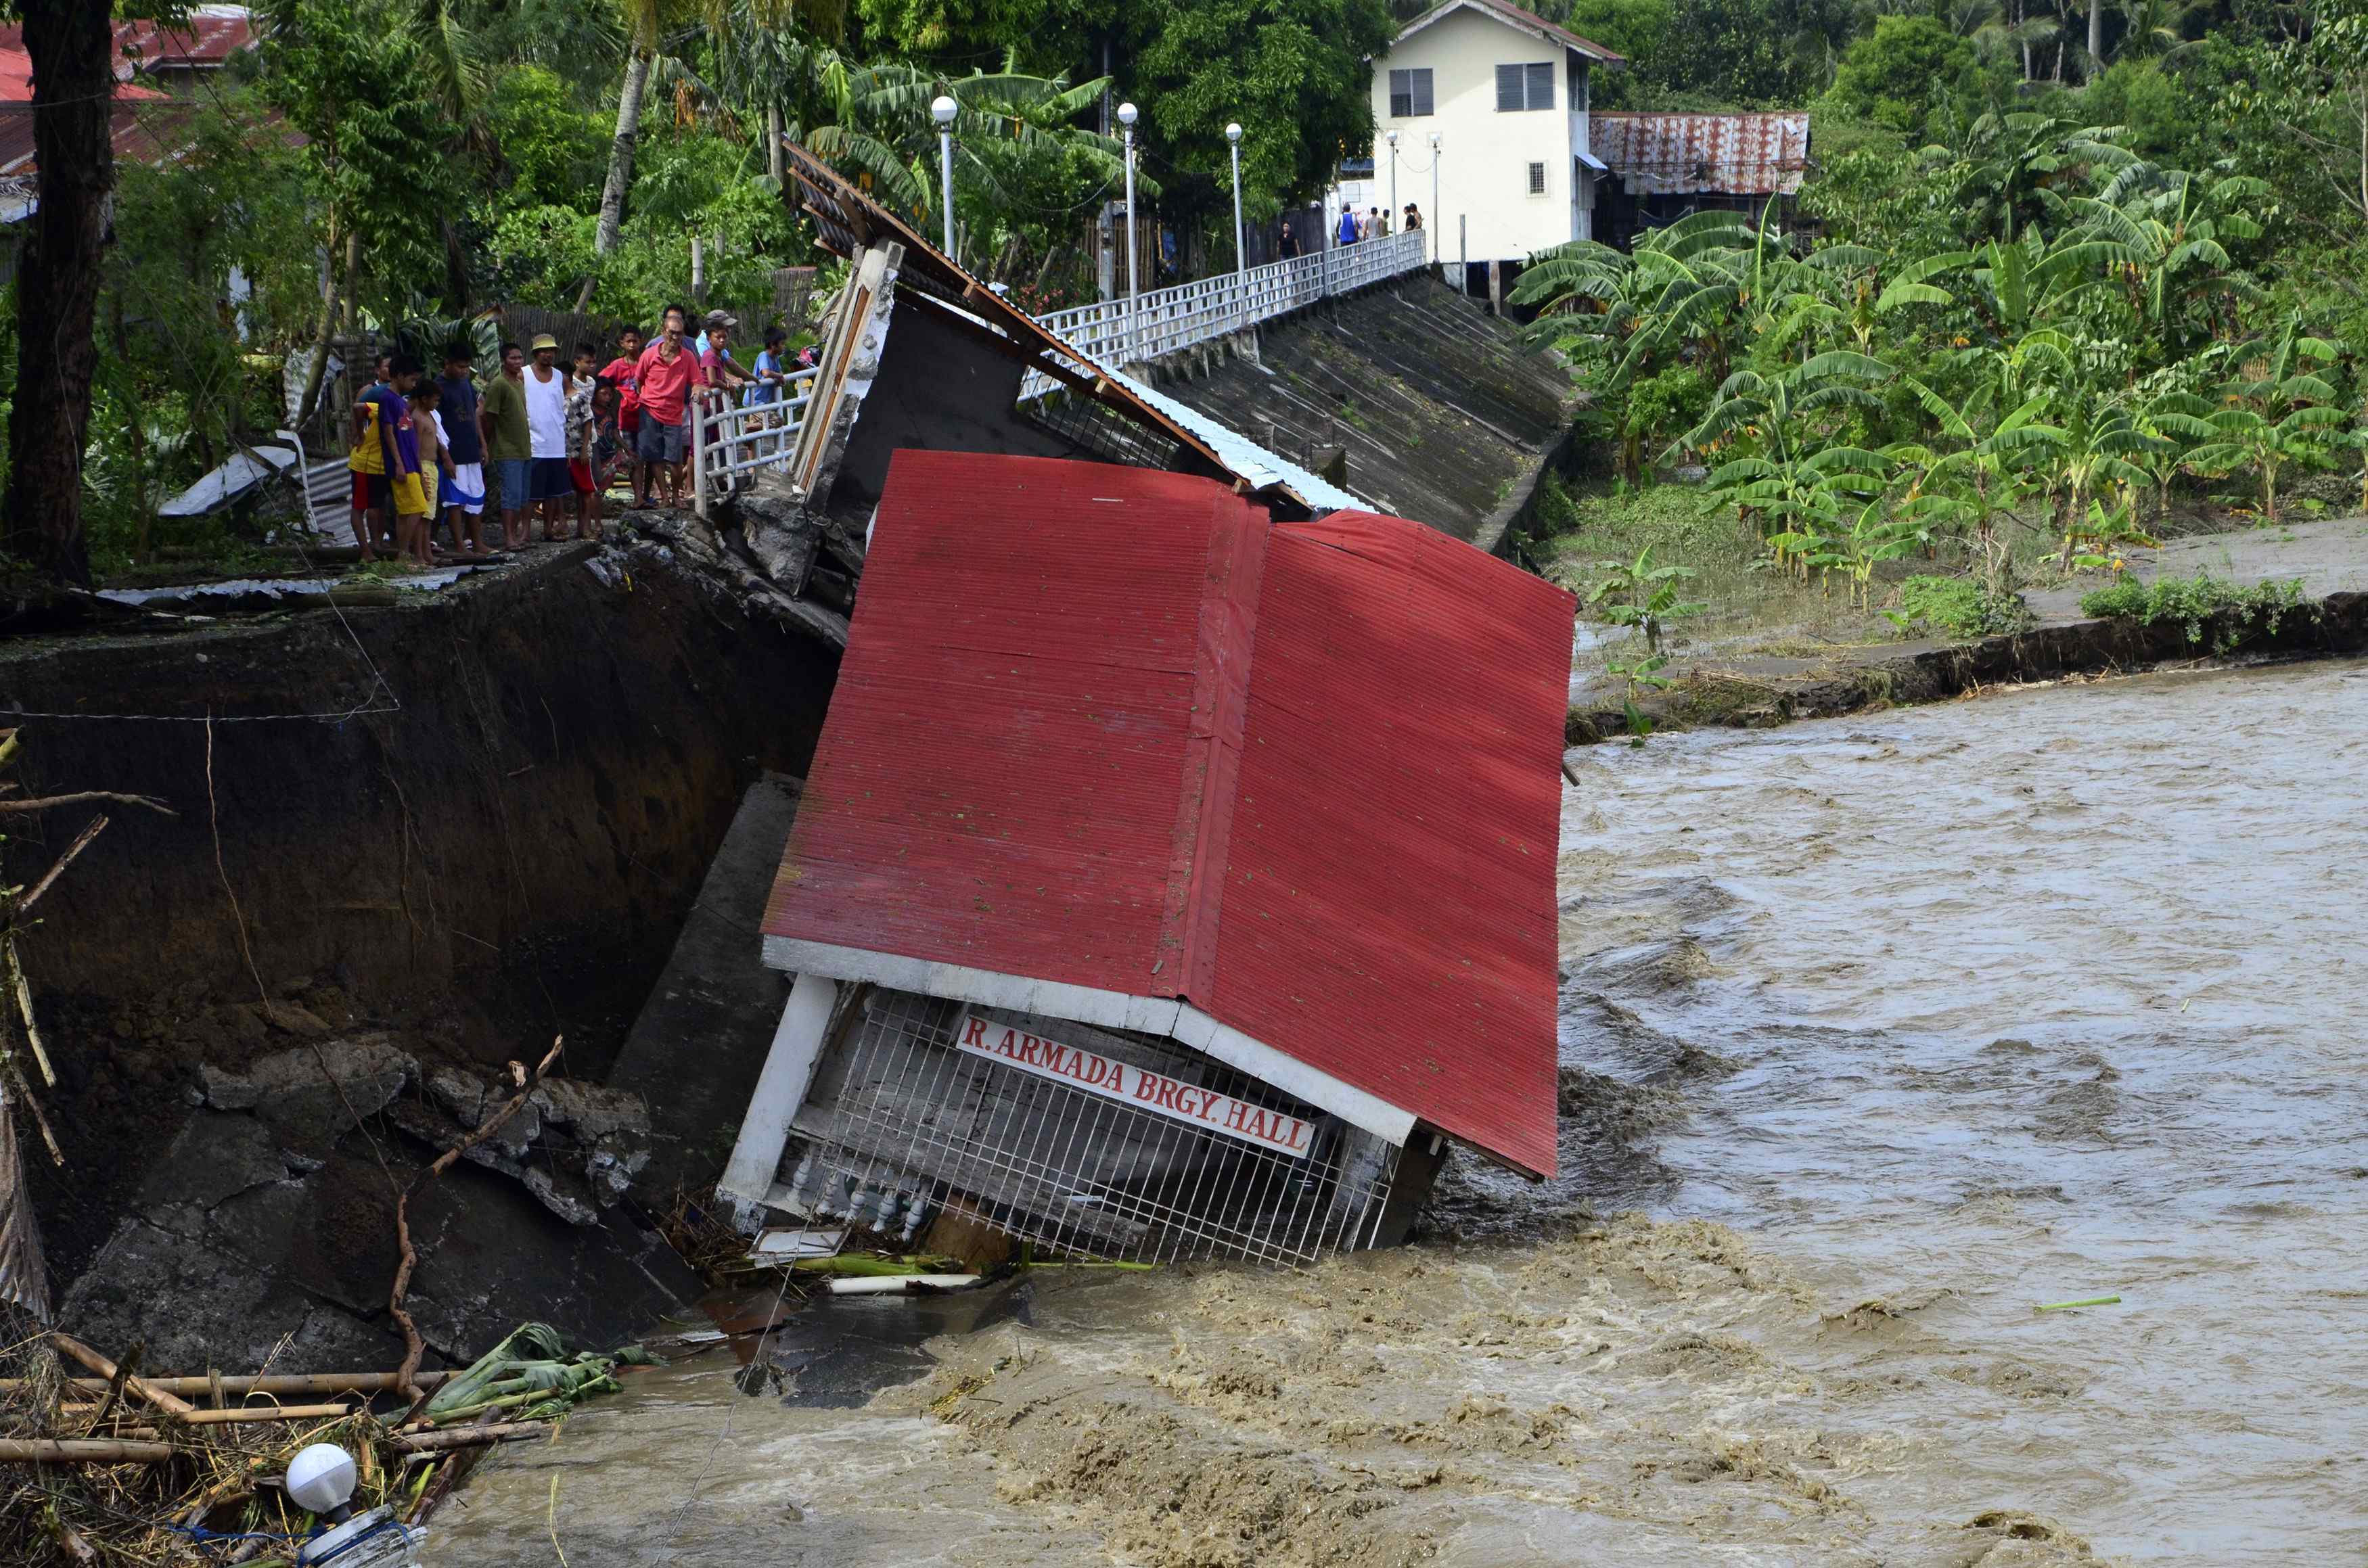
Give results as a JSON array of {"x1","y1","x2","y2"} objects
[{"x1": 1373, "y1": 9, "x2": 1580, "y2": 263}]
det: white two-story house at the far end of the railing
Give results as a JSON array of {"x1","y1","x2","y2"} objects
[{"x1": 1367, "y1": 0, "x2": 1627, "y2": 292}]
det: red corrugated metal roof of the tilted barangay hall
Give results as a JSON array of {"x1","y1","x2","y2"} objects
[{"x1": 765, "y1": 453, "x2": 1572, "y2": 1172}]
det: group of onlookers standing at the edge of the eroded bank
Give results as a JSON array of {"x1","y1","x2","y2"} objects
[{"x1": 348, "y1": 306, "x2": 794, "y2": 566}]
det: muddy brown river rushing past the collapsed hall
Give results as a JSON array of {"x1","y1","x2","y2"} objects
[{"x1": 431, "y1": 663, "x2": 2368, "y2": 1568}]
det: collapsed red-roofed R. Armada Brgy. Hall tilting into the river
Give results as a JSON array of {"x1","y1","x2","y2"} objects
[{"x1": 723, "y1": 450, "x2": 1572, "y2": 1262}]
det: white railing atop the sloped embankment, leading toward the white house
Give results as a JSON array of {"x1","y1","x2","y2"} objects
[{"x1": 1021, "y1": 230, "x2": 1430, "y2": 400}]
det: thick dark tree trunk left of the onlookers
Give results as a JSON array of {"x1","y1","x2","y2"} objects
[{"x1": 5, "y1": 0, "x2": 116, "y2": 585}]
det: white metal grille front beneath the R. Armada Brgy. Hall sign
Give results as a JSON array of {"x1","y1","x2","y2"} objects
[{"x1": 781, "y1": 990, "x2": 1397, "y2": 1262}]
